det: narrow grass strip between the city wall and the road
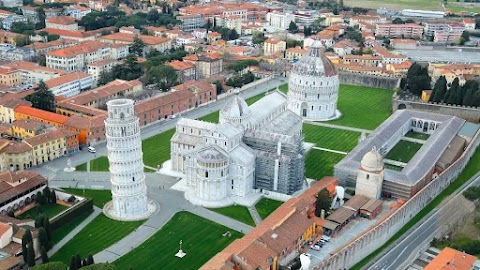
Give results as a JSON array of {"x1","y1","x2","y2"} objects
[{"x1": 351, "y1": 149, "x2": 480, "y2": 270}]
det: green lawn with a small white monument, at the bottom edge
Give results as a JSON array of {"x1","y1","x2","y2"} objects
[{"x1": 114, "y1": 212, "x2": 242, "y2": 270}]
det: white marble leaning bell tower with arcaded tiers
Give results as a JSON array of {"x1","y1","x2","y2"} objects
[{"x1": 104, "y1": 99, "x2": 155, "y2": 220}]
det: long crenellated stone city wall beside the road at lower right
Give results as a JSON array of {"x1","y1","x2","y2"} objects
[{"x1": 312, "y1": 132, "x2": 480, "y2": 270}]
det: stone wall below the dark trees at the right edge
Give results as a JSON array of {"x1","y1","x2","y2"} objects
[{"x1": 392, "y1": 98, "x2": 480, "y2": 123}]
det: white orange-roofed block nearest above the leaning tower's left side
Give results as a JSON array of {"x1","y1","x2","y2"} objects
[{"x1": 45, "y1": 72, "x2": 94, "y2": 98}]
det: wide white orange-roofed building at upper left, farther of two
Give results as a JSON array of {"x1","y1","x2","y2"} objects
[{"x1": 45, "y1": 41, "x2": 112, "y2": 72}]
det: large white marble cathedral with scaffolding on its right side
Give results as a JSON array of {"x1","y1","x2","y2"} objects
[{"x1": 171, "y1": 91, "x2": 305, "y2": 206}]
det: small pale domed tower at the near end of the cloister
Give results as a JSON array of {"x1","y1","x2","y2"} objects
[{"x1": 355, "y1": 148, "x2": 384, "y2": 199}]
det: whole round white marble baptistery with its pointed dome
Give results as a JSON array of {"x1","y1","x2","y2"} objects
[{"x1": 288, "y1": 41, "x2": 340, "y2": 121}]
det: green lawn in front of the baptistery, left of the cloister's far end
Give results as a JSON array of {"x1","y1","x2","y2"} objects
[{"x1": 303, "y1": 124, "x2": 360, "y2": 152}]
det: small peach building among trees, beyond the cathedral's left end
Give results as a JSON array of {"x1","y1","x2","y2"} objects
[{"x1": 183, "y1": 53, "x2": 223, "y2": 80}]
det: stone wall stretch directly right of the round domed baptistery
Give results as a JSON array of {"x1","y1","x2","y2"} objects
[{"x1": 338, "y1": 71, "x2": 400, "y2": 89}]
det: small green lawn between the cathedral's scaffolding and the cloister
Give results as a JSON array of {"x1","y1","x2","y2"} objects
[{"x1": 305, "y1": 149, "x2": 344, "y2": 180}]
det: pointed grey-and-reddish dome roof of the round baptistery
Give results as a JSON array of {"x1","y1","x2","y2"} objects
[{"x1": 292, "y1": 40, "x2": 338, "y2": 77}]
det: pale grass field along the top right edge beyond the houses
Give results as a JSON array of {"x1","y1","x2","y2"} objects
[{"x1": 344, "y1": 0, "x2": 480, "y2": 13}]
